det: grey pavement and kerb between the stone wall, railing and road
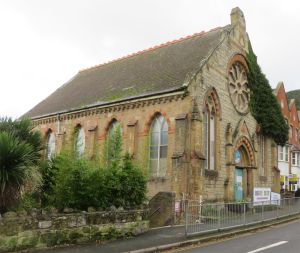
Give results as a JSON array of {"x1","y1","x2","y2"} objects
[{"x1": 35, "y1": 216, "x2": 300, "y2": 253}]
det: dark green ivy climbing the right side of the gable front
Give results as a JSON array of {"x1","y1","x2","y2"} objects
[{"x1": 247, "y1": 43, "x2": 288, "y2": 145}]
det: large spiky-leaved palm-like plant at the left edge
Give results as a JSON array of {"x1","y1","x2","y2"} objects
[{"x1": 0, "y1": 118, "x2": 42, "y2": 211}]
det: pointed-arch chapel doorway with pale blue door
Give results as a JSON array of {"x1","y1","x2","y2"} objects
[{"x1": 234, "y1": 138, "x2": 254, "y2": 201}]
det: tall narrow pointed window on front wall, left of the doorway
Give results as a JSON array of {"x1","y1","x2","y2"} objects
[{"x1": 203, "y1": 95, "x2": 217, "y2": 170}]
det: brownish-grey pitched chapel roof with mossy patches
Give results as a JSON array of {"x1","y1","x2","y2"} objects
[{"x1": 23, "y1": 28, "x2": 223, "y2": 118}]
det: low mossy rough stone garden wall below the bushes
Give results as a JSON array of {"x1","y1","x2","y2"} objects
[{"x1": 0, "y1": 210, "x2": 149, "y2": 252}]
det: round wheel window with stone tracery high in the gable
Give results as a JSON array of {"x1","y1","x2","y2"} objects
[{"x1": 228, "y1": 61, "x2": 250, "y2": 113}]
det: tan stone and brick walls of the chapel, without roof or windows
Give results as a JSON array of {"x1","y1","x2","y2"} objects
[{"x1": 28, "y1": 8, "x2": 280, "y2": 204}]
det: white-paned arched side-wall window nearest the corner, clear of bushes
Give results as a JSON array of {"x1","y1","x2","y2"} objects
[{"x1": 150, "y1": 115, "x2": 168, "y2": 177}]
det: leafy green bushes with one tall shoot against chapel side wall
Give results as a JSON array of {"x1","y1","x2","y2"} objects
[{"x1": 42, "y1": 127, "x2": 147, "y2": 209}]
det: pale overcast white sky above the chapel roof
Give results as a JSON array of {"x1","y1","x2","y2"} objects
[{"x1": 0, "y1": 0, "x2": 300, "y2": 118}]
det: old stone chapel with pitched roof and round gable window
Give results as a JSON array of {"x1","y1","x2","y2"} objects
[{"x1": 25, "y1": 8, "x2": 280, "y2": 201}]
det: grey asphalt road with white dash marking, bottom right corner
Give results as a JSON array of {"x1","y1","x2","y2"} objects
[{"x1": 176, "y1": 221, "x2": 300, "y2": 253}]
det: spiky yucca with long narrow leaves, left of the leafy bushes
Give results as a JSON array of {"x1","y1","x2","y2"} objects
[{"x1": 0, "y1": 121, "x2": 40, "y2": 212}]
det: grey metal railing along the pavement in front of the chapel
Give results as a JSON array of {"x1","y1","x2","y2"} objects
[{"x1": 185, "y1": 198, "x2": 300, "y2": 236}]
